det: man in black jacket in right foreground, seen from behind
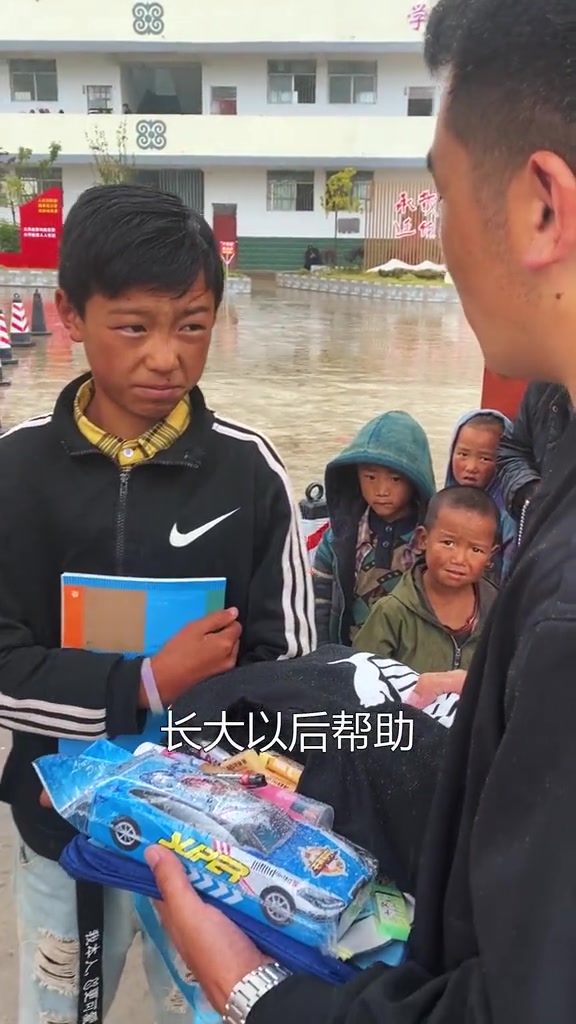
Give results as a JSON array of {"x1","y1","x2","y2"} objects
[{"x1": 140, "y1": 6, "x2": 576, "y2": 1024}]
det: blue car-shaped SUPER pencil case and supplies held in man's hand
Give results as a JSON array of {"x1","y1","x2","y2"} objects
[{"x1": 36, "y1": 740, "x2": 410, "y2": 1024}]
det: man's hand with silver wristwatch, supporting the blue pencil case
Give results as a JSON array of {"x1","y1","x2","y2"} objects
[{"x1": 146, "y1": 846, "x2": 274, "y2": 1014}]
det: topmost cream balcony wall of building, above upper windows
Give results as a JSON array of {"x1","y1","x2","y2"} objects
[{"x1": 1, "y1": 0, "x2": 435, "y2": 55}]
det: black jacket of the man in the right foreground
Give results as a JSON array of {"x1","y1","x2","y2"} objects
[{"x1": 247, "y1": 393, "x2": 576, "y2": 1024}]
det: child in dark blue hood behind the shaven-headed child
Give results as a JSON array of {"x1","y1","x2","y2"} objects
[{"x1": 444, "y1": 409, "x2": 518, "y2": 585}]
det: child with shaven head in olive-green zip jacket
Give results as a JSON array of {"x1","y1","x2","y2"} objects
[{"x1": 354, "y1": 486, "x2": 499, "y2": 689}]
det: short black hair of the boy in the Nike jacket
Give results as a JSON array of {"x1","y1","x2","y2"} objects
[{"x1": 58, "y1": 184, "x2": 224, "y2": 316}]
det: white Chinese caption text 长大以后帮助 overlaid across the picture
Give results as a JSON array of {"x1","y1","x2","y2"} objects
[{"x1": 162, "y1": 708, "x2": 414, "y2": 753}]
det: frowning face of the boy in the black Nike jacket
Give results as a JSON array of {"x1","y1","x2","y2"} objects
[{"x1": 56, "y1": 274, "x2": 215, "y2": 428}]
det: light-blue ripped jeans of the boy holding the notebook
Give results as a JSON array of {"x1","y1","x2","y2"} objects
[{"x1": 14, "y1": 837, "x2": 192, "y2": 1024}]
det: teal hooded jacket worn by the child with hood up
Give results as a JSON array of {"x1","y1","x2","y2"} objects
[{"x1": 313, "y1": 412, "x2": 436, "y2": 645}]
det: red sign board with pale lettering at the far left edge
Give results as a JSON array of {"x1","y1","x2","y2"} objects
[{"x1": 0, "y1": 188, "x2": 63, "y2": 270}]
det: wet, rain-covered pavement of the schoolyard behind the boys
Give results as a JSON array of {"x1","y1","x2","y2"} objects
[{"x1": 0, "y1": 286, "x2": 482, "y2": 1024}]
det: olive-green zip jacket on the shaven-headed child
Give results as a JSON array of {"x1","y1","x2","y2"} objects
[{"x1": 354, "y1": 562, "x2": 497, "y2": 673}]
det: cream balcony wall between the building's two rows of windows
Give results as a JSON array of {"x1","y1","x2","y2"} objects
[{"x1": 0, "y1": 114, "x2": 436, "y2": 168}]
